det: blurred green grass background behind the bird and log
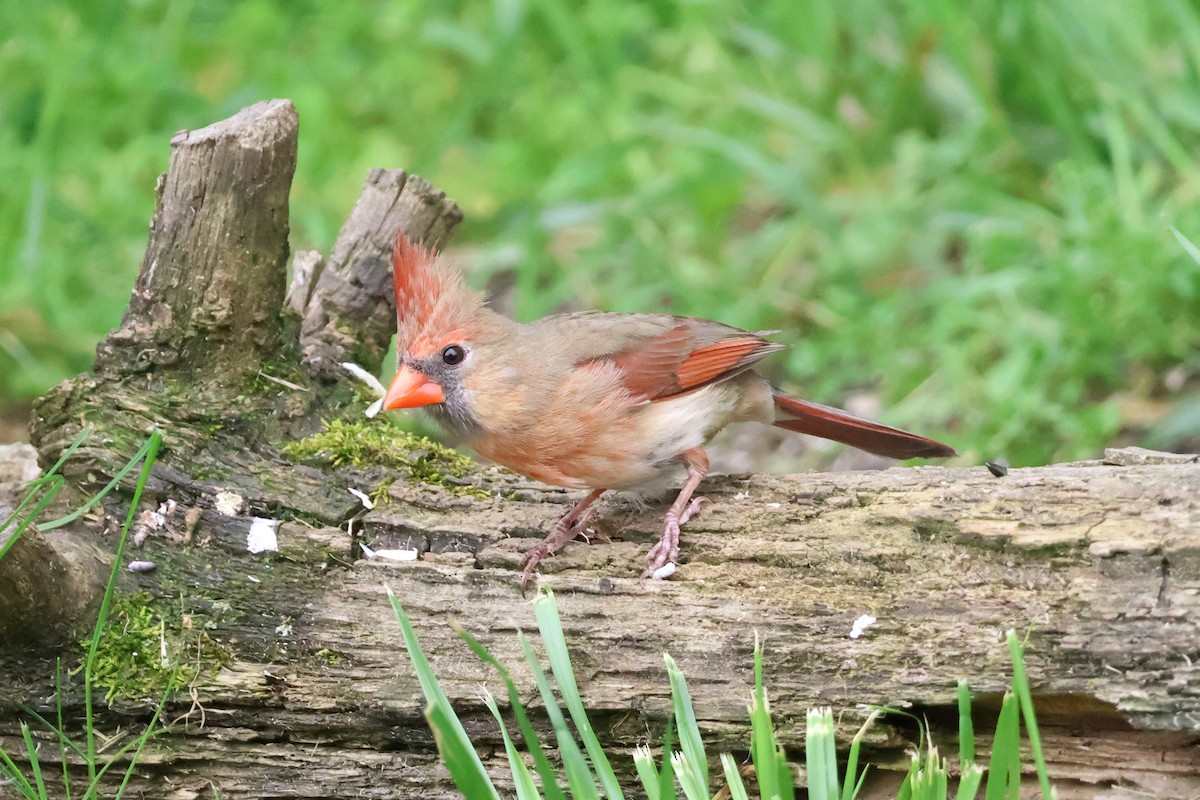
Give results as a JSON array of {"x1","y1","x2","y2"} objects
[{"x1": 0, "y1": 0, "x2": 1200, "y2": 464}]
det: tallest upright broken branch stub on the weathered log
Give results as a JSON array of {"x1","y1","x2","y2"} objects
[{"x1": 95, "y1": 101, "x2": 299, "y2": 380}]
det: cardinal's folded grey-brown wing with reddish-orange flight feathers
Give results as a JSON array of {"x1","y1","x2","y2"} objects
[{"x1": 537, "y1": 312, "x2": 786, "y2": 402}]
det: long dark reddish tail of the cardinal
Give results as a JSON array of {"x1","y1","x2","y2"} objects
[{"x1": 772, "y1": 387, "x2": 958, "y2": 458}]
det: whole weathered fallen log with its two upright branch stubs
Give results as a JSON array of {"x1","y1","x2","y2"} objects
[{"x1": 0, "y1": 101, "x2": 1200, "y2": 799}]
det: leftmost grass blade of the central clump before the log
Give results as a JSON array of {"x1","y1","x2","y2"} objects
[{"x1": 384, "y1": 585, "x2": 500, "y2": 800}]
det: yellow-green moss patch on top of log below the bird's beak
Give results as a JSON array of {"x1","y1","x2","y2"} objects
[{"x1": 282, "y1": 420, "x2": 488, "y2": 497}]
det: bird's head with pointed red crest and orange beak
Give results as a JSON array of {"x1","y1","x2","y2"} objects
[{"x1": 383, "y1": 234, "x2": 486, "y2": 427}]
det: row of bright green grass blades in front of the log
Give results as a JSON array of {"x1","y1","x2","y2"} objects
[{"x1": 388, "y1": 588, "x2": 1056, "y2": 800}]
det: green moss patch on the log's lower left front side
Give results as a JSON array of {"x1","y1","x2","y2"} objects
[{"x1": 77, "y1": 591, "x2": 232, "y2": 703}]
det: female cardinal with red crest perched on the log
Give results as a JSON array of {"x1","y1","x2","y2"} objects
[{"x1": 383, "y1": 235, "x2": 955, "y2": 590}]
